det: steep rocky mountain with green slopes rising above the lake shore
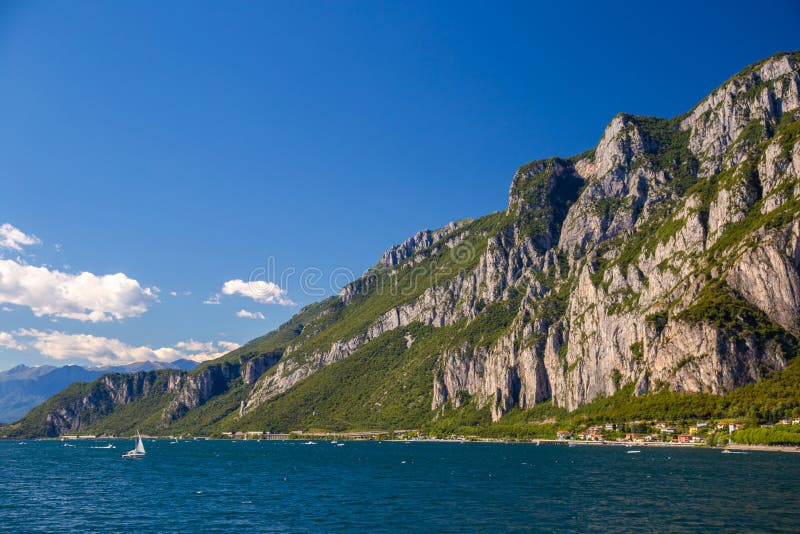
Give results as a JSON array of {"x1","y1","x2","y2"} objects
[{"x1": 6, "y1": 53, "x2": 800, "y2": 435}]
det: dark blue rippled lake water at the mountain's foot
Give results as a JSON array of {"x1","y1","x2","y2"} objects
[{"x1": 0, "y1": 440, "x2": 800, "y2": 532}]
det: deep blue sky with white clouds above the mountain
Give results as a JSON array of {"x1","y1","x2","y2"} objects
[{"x1": 0, "y1": 1, "x2": 800, "y2": 369}]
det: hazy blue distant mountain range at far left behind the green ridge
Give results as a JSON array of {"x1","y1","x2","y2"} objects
[{"x1": 0, "y1": 359, "x2": 197, "y2": 423}]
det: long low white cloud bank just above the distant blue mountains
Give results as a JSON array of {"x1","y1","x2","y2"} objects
[{"x1": 10, "y1": 329, "x2": 239, "y2": 365}]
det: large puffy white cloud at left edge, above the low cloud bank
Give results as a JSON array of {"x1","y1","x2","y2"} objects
[{"x1": 0, "y1": 260, "x2": 158, "y2": 322}]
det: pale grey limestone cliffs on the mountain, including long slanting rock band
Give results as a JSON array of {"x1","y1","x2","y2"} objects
[{"x1": 242, "y1": 54, "x2": 800, "y2": 419}]
